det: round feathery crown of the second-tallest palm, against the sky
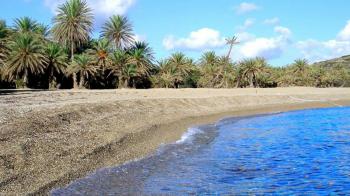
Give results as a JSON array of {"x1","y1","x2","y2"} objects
[{"x1": 102, "y1": 15, "x2": 134, "y2": 49}]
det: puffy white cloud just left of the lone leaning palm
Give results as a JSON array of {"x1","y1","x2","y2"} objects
[{"x1": 163, "y1": 28, "x2": 226, "y2": 50}]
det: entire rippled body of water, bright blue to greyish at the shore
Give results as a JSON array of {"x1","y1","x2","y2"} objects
[{"x1": 52, "y1": 107, "x2": 350, "y2": 195}]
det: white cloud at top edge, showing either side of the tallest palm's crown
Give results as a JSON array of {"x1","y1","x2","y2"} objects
[{"x1": 44, "y1": 0, "x2": 135, "y2": 17}]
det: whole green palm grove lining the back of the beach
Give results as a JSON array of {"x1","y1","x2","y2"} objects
[{"x1": 0, "y1": 0, "x2": 350, "y2": 89}]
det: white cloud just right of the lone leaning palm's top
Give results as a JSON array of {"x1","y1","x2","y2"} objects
[{"x1": 239, "y1": 26, "x2": 292, "y2": 59}]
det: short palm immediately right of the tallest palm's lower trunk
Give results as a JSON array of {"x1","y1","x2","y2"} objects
[{"x1": 67, "y1": 53, "x2": 97, "y2": 88}]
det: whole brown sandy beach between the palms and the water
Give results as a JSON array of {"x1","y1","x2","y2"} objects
[{"x1": 0, "y1": 88, "x2": 350, "y2": 195}]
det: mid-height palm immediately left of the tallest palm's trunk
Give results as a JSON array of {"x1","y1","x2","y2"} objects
[{"x1": 44, "y1": 43, "x2": 67, "y2": 88}]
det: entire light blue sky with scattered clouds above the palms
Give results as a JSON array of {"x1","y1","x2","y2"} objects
[{"x1": 0, "y1": 0, "x2": 350, "y2": 66}]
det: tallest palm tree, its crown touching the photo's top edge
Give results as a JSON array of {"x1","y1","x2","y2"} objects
[{"x1": 52, "y1": 0, "x2": 93, "y2": 88}]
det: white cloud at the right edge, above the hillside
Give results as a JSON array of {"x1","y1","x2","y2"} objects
[{"x1": 296, "y1": 21, "x2": 350, "y2": 62}]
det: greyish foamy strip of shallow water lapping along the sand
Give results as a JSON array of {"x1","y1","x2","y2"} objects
[{"x1": 51, "y1": 108, "x2": 348, "y2": 195}]
